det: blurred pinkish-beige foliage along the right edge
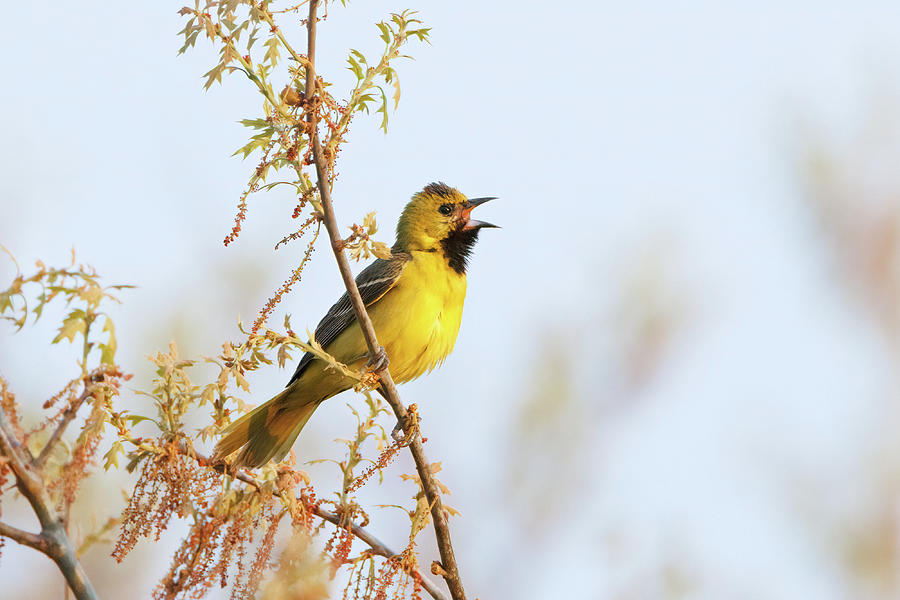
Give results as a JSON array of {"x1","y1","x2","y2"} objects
[{"x1": 802, "y1": 102, "x2": 900, "y2": 598}]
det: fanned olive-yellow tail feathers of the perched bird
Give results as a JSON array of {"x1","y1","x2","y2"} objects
[{"x1": 212, "y1": 388, "x2": 319, "y2": 468}]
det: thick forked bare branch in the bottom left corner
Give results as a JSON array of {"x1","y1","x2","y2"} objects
[{"x1": 0, "y1": 407, "x2": 97, "y2": 600}]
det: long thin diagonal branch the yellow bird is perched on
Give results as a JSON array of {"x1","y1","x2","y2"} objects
[{"x1": 306, "y1": 0, "x2": 466, "y2": 600}]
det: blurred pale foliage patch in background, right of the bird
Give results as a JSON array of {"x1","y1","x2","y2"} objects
[{"x1": 502, "y1": 241, "x2": 696, "y2": 599}]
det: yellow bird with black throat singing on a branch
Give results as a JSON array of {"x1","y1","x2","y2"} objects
[{"x1": 212, "y1": 182, "x2": 497, "y2": 468}]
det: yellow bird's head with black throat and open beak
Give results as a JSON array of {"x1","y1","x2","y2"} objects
[{"x1": 394, "y1": 183, "x2": 497, "y2": 273}]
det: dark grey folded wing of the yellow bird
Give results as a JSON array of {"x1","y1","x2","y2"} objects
[{"x1": 287, "y1": 253, "x2": 411, "y2": 385}]
